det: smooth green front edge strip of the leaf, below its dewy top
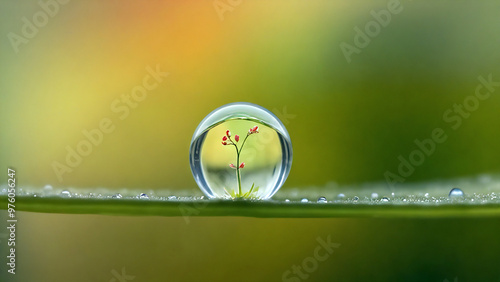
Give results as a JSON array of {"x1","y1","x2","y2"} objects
[{"x1": 0, "y1": 196, "x2": 500, "y2": 218}]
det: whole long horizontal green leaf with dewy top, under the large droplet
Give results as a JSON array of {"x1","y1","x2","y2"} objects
[{"x1": 0, "y1": 176, "x2": 500, "y2": 218}]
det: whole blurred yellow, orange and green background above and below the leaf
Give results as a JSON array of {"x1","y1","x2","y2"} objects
[{"x1": 0, "y1": 0, "x2": 500, "y2": 281}]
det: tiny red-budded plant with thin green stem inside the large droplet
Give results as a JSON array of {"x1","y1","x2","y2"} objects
[{"x1": 222, "y1": 126, "x2": 259, "y2": 199}]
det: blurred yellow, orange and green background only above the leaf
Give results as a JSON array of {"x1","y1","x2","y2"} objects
[{"x1": 0, "y1": 1, "x2": 500, "y2": 192}]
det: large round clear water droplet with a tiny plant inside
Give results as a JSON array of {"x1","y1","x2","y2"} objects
[{"x1": 189, "y1": 103, "x2": 292, "y2": 199}]
